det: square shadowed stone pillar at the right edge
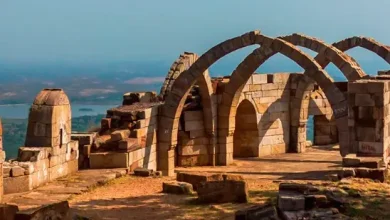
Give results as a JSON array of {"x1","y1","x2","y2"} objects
[{"x1": 348, "y1": 79, "x2": 390, "y2": 161}]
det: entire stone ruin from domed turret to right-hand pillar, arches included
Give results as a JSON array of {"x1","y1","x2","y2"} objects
[{"x1": 0, "y1": 31, "x2": 390, "y2": 206}]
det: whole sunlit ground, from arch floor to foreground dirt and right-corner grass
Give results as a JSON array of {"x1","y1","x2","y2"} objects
[{"x1": 70, "y1": 145, "x2": 390, "y2": 220}]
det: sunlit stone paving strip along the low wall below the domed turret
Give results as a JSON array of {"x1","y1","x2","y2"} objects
[{"x1": 3, "y1": 169, "x2": 126, "y2": 210}]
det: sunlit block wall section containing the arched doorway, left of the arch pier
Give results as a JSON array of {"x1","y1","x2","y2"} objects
[{"x1": 217, "y1": 73, "x2": 291, "y2": 157}]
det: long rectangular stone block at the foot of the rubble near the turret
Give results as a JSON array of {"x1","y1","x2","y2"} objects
[{"x1": 89, "y1": 152, "x2": 129, "y2": 169}]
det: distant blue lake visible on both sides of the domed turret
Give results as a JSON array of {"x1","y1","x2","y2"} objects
[{"x1": 0, "y1": 104, "x2": 116, "y2": 119}]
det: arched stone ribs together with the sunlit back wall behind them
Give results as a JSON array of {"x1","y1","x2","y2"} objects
[{"x1": 157, "y1": 31, "x2": 390, "y2": 175}]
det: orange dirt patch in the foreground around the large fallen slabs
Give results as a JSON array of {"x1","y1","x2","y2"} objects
[{"x1": 70, "y1": 176, "x2": 278, "y2": 220}]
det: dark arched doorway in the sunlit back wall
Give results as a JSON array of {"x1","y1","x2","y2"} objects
[{"x1": 233, "y1": 99, "x2": 260, "y2": 157}]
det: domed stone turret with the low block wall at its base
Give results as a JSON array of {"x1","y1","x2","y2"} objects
[{"x1": 3, "y1": 89, "x2": 79, "y2": 194}]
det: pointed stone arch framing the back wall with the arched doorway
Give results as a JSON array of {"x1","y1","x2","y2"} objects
[{"x1": 218, "y1": 36, "x2": 358, "y2": 164}]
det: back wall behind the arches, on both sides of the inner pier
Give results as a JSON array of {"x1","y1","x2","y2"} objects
[{"x1": 209, "y1": 73, "x2": 338, "y2": 160}]
